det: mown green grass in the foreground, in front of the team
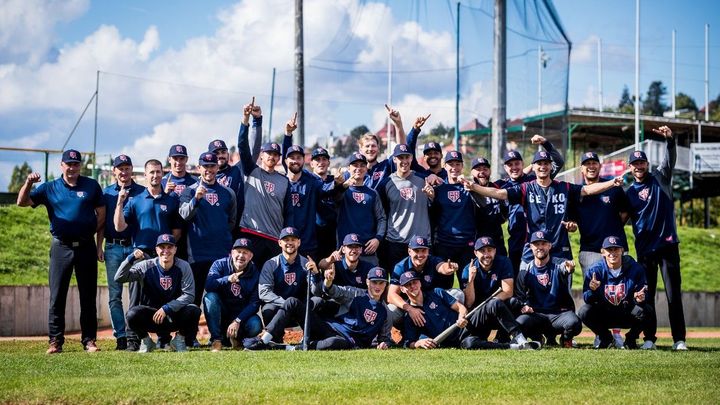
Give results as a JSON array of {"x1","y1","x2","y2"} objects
[{"x1": 0, "y1": 332, "x2": 720, "y2": 404}]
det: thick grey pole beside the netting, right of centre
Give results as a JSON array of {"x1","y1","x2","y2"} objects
[{"x1": 490, "y1": 0, "x2": 507, "y2": 178}]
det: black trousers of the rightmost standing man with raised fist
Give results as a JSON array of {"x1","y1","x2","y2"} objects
[{"x1": 638, "y1": 243, "x2": 685, "y2": 342}]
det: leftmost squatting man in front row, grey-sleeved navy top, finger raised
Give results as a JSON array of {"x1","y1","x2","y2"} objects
[{"x1": 115, "y1": 234, "x2": 200, "y2": 353}]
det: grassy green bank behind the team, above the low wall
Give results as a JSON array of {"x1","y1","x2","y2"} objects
[{"x1": 0, "y1": 206, "x2": 720, "y2": 292}]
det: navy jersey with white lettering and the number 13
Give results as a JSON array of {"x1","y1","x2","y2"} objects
[{"x1": 508, "y1": 180, "x2": 582, "y2": 261}]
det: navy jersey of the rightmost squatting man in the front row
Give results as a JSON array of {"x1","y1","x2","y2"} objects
[{"x1": 583, "y1": 256, "x2": 647, "y2": 307}]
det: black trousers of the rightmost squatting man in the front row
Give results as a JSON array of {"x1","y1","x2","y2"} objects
[{"x1": 578, "y1": 303, "x2": 655, "y2": 347}]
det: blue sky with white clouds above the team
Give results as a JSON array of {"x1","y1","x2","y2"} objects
[{"x1": 0, "y1": 0, "x2": 720, "y2": 190}]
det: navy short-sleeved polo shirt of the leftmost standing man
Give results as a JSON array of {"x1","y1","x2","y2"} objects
[{"x1": 30, "y1": 176, "x2": 103, "y2": 238}]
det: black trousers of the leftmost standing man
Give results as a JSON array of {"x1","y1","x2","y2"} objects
[{"x1": 48, "y1": 238, "x2": 97, "y2": 345}]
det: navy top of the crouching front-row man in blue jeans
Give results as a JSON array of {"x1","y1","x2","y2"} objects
[{"x1": 205, "y1": 257, "x2": 260, "y2": 322}]
